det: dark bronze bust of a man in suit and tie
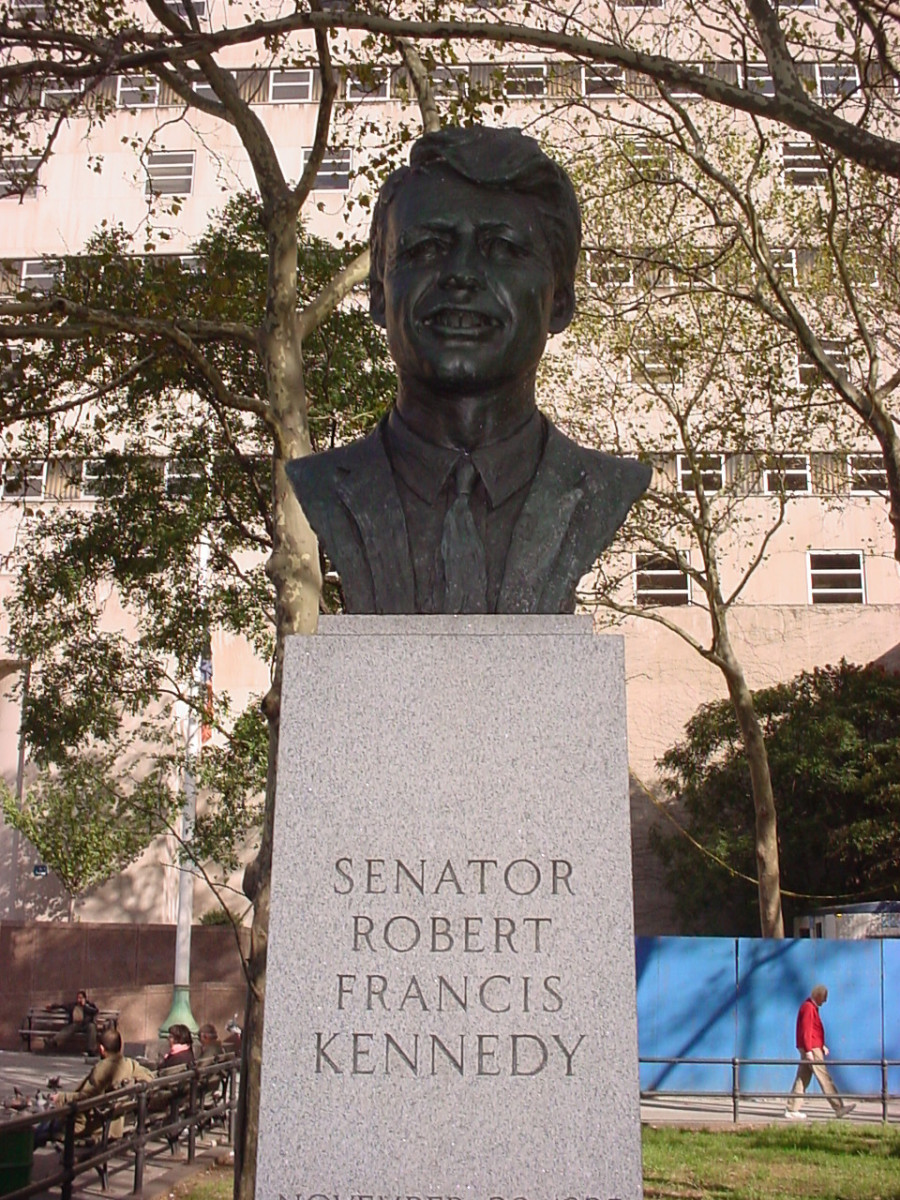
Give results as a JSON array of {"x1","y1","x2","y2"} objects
[{"x1": 288, "y1": 127, "x2": 650, "y2": 613}]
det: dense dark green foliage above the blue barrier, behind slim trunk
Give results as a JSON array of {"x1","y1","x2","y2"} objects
[{"x1": 655, "y1": 662, "x2": 900, "y2": 935}]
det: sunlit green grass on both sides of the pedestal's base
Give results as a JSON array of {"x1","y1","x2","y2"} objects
[{"x1": 178, "y1": 1122, "x2": 900, "y2": 1200}]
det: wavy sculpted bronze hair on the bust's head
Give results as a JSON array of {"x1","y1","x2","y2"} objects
[{"x1": 370, "y1": 126, "x2": 581, "y2": 287}]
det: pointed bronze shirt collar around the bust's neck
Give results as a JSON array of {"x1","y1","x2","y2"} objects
[{"x1": 386, "y1": 408, "x2": 546, "y2": 509}]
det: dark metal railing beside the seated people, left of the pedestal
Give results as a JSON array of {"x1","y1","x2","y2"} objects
[{"x1": 0, "y1": 1058, "x2": 239, "y2": 1200}]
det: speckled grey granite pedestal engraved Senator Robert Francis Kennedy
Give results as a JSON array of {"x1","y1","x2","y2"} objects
[{"x1": 257, "y1": 617, "x2": 642, "y2": 1200}]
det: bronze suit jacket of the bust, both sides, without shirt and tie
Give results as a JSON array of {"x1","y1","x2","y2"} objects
[{"x1": 287, "y1": 421, "x2": 650, "y2": 614}]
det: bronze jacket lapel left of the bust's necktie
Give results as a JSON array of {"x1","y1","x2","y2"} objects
[{"x1": 335, "y1": 428, "x2": 415, "y2": 613}]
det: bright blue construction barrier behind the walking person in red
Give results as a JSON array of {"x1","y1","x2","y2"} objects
[{"x1": 636, "y1": 937, "x2": 900, "y2": 1093}]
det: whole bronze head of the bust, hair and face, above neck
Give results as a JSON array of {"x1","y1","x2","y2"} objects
[{"x1": 370, "y1": 126, "x2": 581, "y2": 394}]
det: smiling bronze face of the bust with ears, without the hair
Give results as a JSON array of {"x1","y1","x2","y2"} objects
[{"x1": 371, "y1": 170, "x2": 574, "y2": 394}]
